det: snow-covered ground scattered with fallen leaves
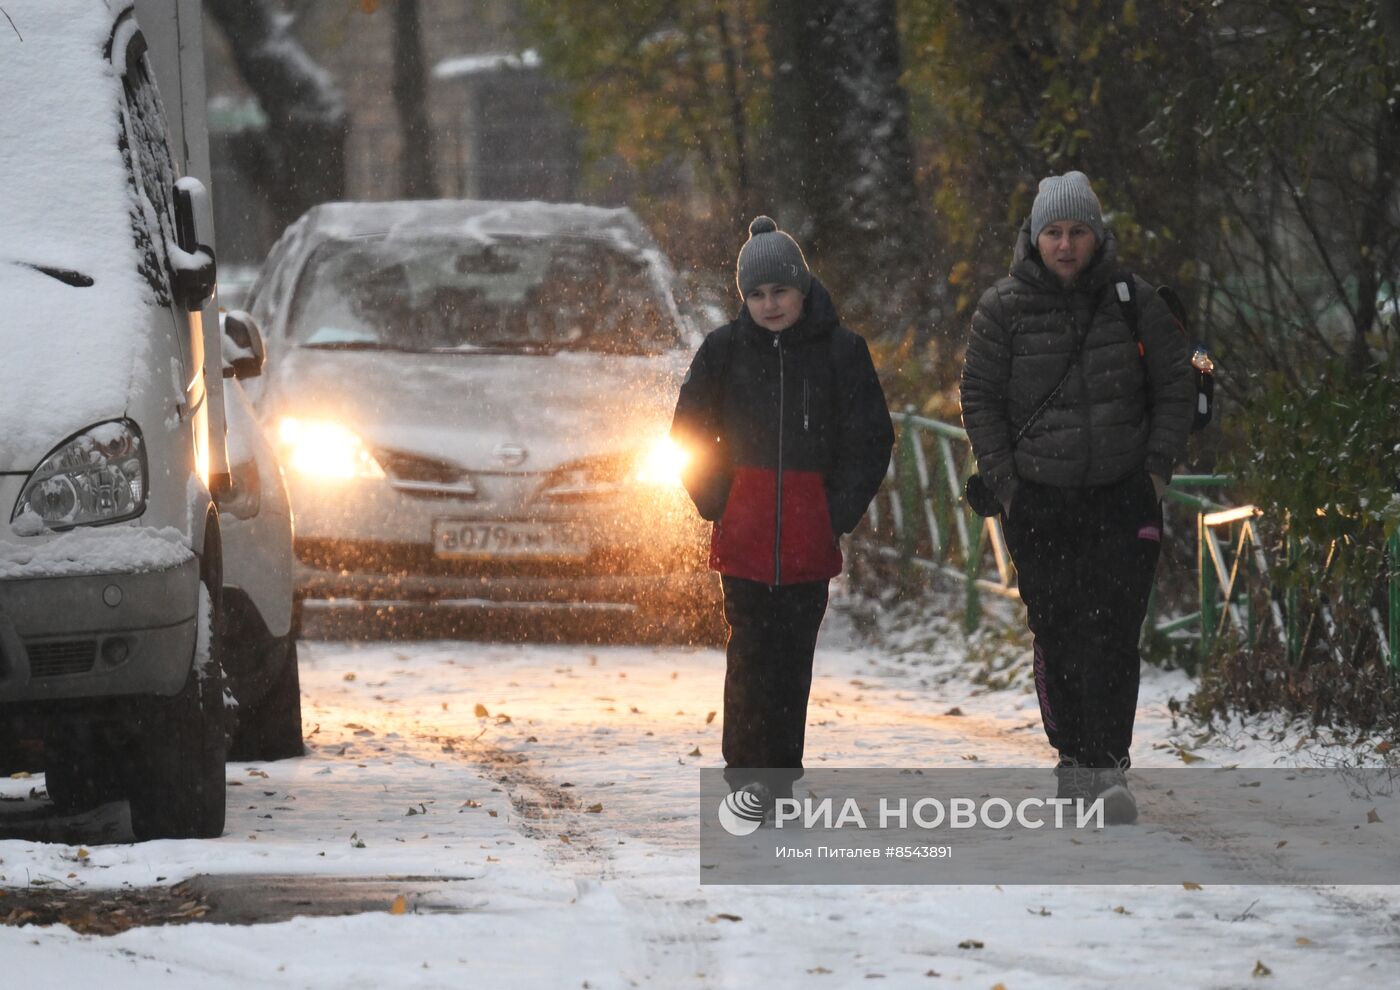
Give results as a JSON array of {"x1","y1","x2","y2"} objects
[{"x1": 0, "y1": 593, "x2": 1400, "y2": 990}]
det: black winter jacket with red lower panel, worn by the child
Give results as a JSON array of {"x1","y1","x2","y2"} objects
[{"x1": 671, "y1": 280, "x2": 895, "y2": 584}]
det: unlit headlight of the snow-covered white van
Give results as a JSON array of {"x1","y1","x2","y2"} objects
[{"x1": 10, "y1": 419, "x2": 147, "y2": 529}]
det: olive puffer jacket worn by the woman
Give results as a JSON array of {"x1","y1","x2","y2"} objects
[{"x1": 962, "y1": 221, "x2": 1193, "y2": 504}]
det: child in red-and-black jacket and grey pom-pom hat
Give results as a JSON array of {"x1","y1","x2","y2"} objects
[{"x1": 672, "y1": 217, "x2": 895, "y2": 809}]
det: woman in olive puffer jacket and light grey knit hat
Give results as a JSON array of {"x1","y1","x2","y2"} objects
[{"x1": 962, "y1": 172, "x2": 1193, "y2": 823}]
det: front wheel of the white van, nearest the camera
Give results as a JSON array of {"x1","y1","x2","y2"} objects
[{"x1": 126, "y1": 591, "x2": 228, "y2": 842}]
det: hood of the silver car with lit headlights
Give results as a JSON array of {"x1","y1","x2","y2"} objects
[{"x1": 259, "y1": 347, "x2": 689, "y2": 472}]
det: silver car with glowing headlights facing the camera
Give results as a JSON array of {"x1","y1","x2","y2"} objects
[{"x1": 249, "y1": 202, "x2": 721, "y2": 636}]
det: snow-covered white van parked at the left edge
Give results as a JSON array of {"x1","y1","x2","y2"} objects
[{"x1": 0, "y1": 0, "x2": 227, "y2": 839}]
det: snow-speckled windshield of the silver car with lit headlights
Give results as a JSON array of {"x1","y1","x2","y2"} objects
[{"x1": 288, "y1": 237, "x2": 680, "y2": 354}]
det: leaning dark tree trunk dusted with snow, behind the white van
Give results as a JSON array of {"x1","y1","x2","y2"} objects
[{"x1": 204, "y1": 0, "x2": 349, "y2": 225}]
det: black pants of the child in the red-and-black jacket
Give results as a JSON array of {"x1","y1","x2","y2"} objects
[{"x1": 722, "y1": 577, "x2": 827, "y2": 798}]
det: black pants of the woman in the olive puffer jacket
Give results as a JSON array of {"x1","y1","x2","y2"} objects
[{"x1": 1005, "y1": 472, "x2": 1162, "y2": 767}]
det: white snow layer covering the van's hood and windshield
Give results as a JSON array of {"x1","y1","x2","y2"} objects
[{"x1": 0, "y1": 0, "x2": 148, "y2": 470}]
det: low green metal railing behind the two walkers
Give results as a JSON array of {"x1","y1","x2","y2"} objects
[{"x1": 867, "y1": 412, "x2": 1400, "y2": 674}]
